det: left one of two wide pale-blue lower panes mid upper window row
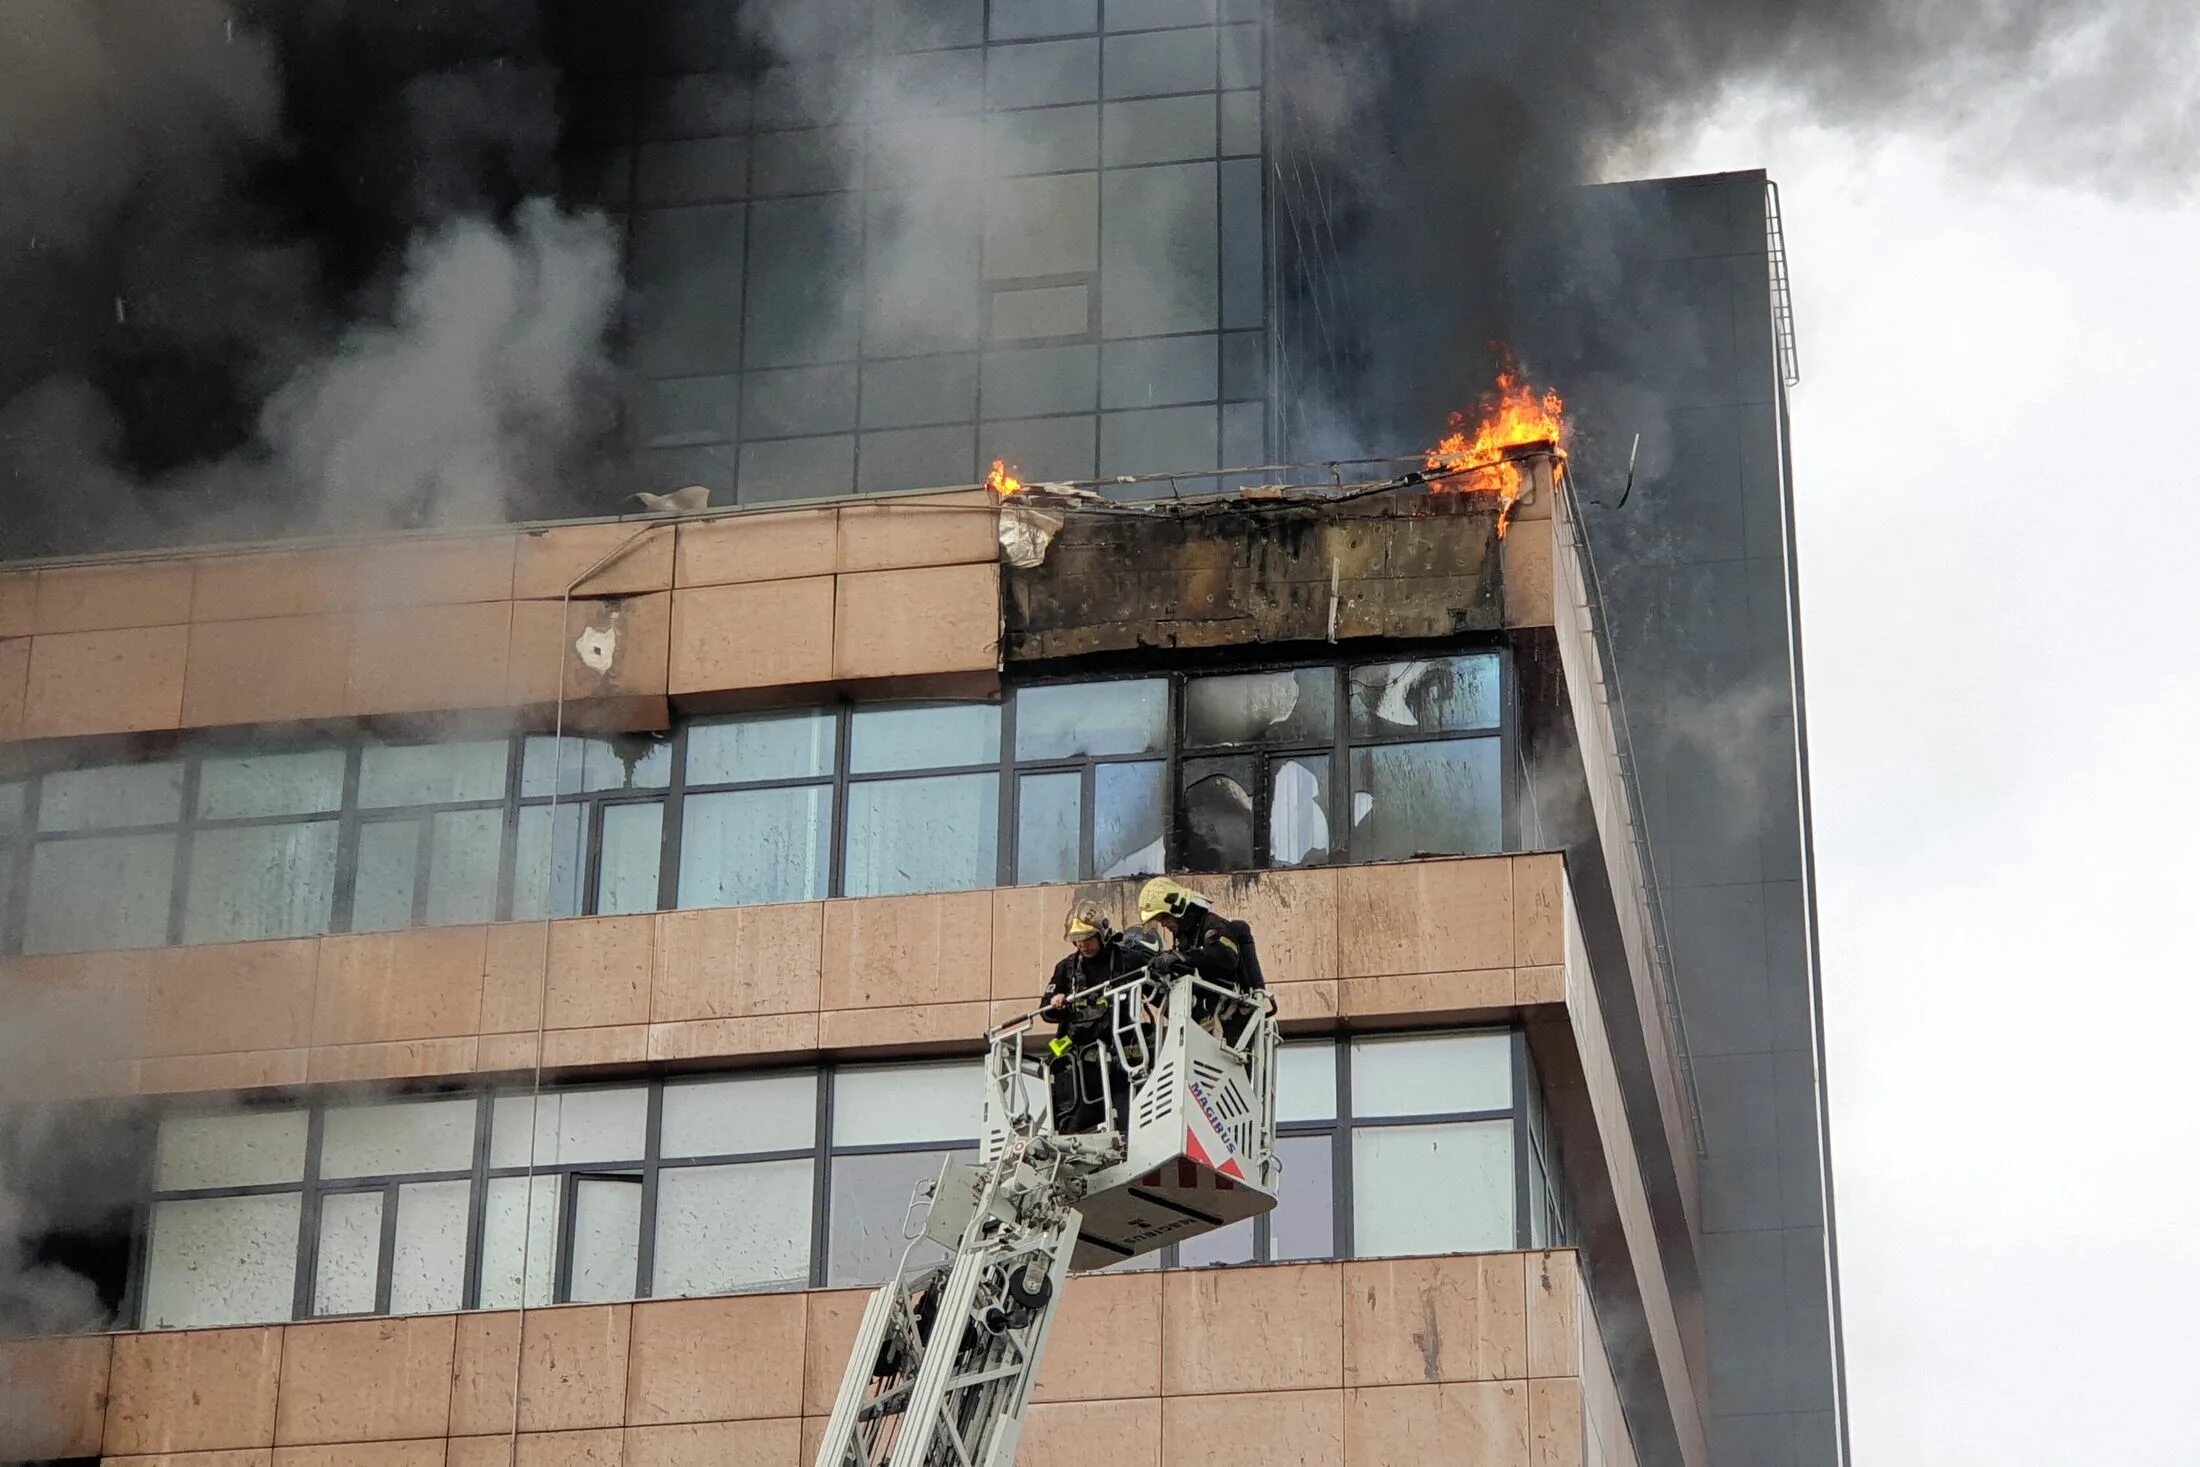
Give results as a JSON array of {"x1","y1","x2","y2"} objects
[{"x1": 680, "y1": 785, "x2": 832, "y2": 906}]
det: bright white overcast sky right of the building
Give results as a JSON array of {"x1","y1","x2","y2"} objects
[{"x1": 1646, "y1": 103, "x2": 2200, "y2": 1467}]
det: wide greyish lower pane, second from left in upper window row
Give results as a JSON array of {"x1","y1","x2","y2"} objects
[{"x1": 183, "y1": 820, "x2": 337, "y2": 941}]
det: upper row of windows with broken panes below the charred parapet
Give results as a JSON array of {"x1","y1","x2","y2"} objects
[{"x1": 0, "y1": 651, "x2": 1509, "y2": 954}]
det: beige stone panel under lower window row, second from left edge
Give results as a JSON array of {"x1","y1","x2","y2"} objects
[{"x1": 101, "y1": 1326, "x2": 284, "y2": 1456}]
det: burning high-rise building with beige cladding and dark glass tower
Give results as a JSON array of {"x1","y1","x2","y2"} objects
[{"x1": 0, "y1": 0, "x2": 1846, "y2": 1467}]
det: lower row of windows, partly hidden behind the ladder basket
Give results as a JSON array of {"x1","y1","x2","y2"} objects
[{"x1": 136, "y1": 1029, "x2": 1571, "y2": 1328}]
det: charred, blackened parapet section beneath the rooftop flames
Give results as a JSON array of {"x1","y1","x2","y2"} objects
[{"x1": 999, "y1": 451, "x2": 1555, "y2": 662}]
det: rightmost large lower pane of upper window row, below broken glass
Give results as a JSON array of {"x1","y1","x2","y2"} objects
[{"x1": 1353, "y1": 739, "x2": 1503, "y2": 860}]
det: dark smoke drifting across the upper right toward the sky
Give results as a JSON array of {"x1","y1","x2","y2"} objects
[{"x1": 1269, "y1": 0, "x2": 2200, "y2": 453}]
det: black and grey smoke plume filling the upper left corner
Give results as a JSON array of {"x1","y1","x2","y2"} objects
[{"x1": 0, "y1": 0, "x2": 618, "y2": 554}]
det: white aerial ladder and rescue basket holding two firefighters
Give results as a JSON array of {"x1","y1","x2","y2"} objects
[{"x1": 816, "y1": 968, "x2": 1283, "y2": 1467}]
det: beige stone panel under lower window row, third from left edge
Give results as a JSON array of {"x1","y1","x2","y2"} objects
[{"x1": 275, "y1": 1315, "x2": 458, "y2": 1447}]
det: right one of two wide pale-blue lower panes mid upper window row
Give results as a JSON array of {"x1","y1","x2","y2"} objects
[{"x1": 843, "y1": 772, "x2": 1001, "y2": 897}]
